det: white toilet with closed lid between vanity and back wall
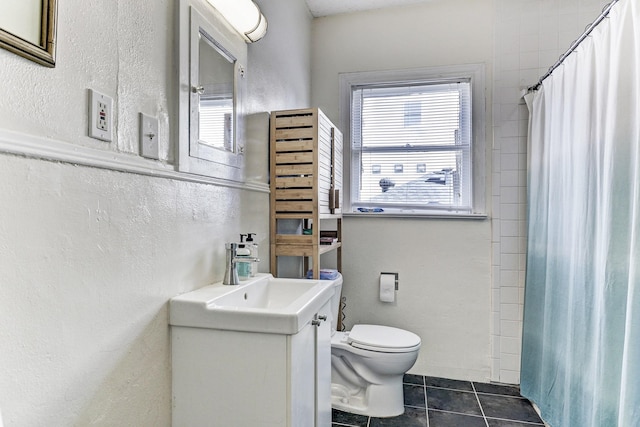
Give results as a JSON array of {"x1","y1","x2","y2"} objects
[{"x1": 331, "y1": 277, "x2": 420, "y2": 417}]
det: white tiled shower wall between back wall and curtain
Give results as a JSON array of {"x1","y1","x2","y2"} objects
[{"x1": 491, "y1": 0, "x2": 612, "y2": 384}]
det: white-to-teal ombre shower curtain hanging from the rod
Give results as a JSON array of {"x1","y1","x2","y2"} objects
[{"x1": 521, "y1": 0, "x2": 640, "y2": 427}]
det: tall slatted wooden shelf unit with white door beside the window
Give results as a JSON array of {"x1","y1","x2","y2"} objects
[{"x1": 269, "y1": 108, "x2": 342, "y2": 279}]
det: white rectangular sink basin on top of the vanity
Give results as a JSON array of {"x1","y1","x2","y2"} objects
[{"x1": 169, "y1": 274, "x2": 342, "y2": 334}]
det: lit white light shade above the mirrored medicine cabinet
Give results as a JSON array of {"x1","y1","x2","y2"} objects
[{"x1": 207, "y1": 0, "x2": 267, "y2": 43}]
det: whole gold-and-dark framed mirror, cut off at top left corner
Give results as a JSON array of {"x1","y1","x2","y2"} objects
[{"x1": 0, "y1": 0, "x2": 57, "y2": 67}]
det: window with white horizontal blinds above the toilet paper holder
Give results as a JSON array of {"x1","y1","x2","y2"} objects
[{"x1": 341, "y1": 66, "x2": 484, "y2": 214}]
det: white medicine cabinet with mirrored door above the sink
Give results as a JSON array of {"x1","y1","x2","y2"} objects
[{"x1": 178, "y1": 0, "x2": 247, "y2": 182}]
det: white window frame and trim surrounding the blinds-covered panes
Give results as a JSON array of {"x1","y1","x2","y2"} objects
[{"x1": 339, "y1": 64, "x2": 486, "y2": 218}]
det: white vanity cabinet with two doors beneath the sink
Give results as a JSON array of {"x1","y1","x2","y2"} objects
[{"x1": 171, "y1": 302, "x2": 331, "y2": 427}]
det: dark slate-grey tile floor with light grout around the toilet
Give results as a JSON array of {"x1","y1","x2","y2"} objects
[{"x1": 332, "y1": 375, "x2": 544, "y2": 427}]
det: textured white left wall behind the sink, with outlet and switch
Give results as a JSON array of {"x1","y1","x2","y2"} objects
[{"x1": 0, "y1": 0, "x2": 311, "y2": 427}]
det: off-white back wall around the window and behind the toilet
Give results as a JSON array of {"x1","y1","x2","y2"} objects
[{"x1": 312, "y1": 0, "x2": 494, "y2": 381}]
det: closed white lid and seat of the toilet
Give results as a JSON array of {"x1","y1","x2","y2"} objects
[{"x1": 349, "y1": 325, "x2": 420, "y2": 353}]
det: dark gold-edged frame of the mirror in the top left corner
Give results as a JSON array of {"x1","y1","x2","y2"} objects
[{"x1": 0, "y1": 0, "x2": 58, "y2": 68}]
